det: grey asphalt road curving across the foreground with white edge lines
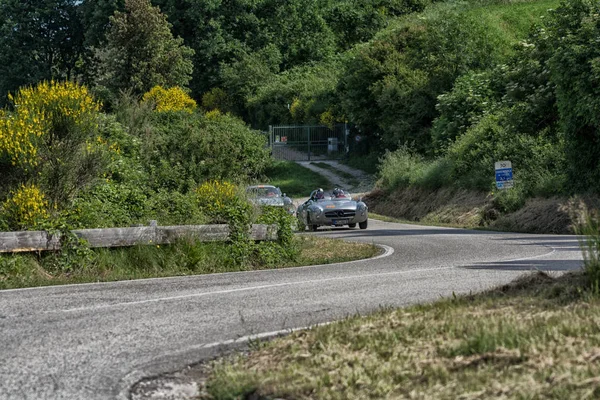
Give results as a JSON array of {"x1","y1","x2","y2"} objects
[{"x1": 0, "y1": 220, "x2": 582, "y2": 399}]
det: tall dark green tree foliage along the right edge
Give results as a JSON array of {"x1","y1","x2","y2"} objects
[{"x1": 545, "y1": 0, "x2": 600, "y2": 192}]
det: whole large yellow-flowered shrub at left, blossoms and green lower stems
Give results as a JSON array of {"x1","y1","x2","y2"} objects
[{"x1": 0, "y1": 81, "x2": 108, "y2": 206}]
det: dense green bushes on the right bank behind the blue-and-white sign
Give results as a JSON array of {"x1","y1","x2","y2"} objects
[{"x1": 382, "y1": 0, "x2": 600, "y2": 206}]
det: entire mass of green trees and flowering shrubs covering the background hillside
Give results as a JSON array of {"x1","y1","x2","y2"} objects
[{"x1": 0, "y1": 0, "x2": 600, "y2": 234}]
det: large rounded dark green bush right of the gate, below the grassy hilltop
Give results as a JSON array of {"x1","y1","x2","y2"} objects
[{"x1": 338, "y1": 4, "x2": 505, "y2": 152}]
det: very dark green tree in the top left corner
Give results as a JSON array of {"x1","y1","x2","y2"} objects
[{"x1": 0, "y1": 0, "x2": 84, "y2": 105}]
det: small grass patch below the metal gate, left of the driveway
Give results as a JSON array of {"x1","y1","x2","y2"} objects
[{"x1": 265, "y1": 161, "x2": 331, "y2": 197}]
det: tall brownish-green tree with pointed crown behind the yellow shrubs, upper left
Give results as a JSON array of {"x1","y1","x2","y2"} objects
[{"x1": 100, "y1": 0, "x2": 194, "y2": 94}]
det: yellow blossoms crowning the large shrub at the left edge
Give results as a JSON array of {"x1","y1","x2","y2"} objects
[{"x1": 0, "y1": 81, "x2": 100, "y2": 167}]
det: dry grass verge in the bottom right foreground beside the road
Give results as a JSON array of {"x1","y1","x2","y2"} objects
[{"x1": 204, "y1": 272, "x2": 600, "y2": 399}]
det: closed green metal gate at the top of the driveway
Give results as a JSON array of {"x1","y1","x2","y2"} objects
[{"x1": 269, "y1": 124, "x2": 349, "y2": 161}]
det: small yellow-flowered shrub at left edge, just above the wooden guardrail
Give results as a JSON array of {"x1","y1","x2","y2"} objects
[{"x1": 2, "y1": 184, "x2": 48, "y2": 229}]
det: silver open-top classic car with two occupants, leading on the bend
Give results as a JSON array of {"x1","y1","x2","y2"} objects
[{"x1": 296, "y1": 188, "x2": 369, "y2": 231}]
